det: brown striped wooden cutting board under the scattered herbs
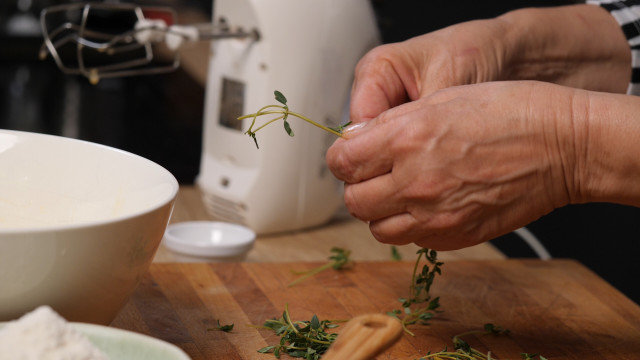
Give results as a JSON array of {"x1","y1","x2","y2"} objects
[{"x1": 113, "y1": 260, "x2": 640, "y2": 360}]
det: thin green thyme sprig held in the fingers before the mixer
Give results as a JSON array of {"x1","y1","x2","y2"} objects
[{"x1": 238, "y1": 90, "x2": 351, "y2": 149}]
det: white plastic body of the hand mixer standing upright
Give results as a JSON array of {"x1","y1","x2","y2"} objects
[{"x1": 197, "y1": 0, "x2": 378, "y2": 233}]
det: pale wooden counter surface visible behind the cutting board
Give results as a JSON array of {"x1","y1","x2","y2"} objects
[{"x1": 154, "y1": 186, "x2": 504, "y2": 262}]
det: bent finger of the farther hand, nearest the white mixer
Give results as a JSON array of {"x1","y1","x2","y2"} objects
[{"x1": 351, "y1": 44, "x2": 416, "y2": 123}]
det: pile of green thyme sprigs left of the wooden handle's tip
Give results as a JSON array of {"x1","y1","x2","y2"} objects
[{"x1": 258, "y1": 305, "x2": 344, "y2": 360}]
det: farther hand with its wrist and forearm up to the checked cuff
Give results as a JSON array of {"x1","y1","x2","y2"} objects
[{"x1": 351, "y1": 5, "x2": 631, "y2": 123}]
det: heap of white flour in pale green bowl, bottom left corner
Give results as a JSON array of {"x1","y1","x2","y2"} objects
[{"x1": 0, "y1": 306, "x2": 190, "y2": 360}]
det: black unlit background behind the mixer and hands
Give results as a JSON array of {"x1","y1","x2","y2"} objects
[{"x1": 0, "y1": 0, "x2": 640, "y2": 302}]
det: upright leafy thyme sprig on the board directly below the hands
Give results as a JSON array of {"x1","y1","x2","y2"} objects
[{"x1": 387, "y1": 249, "x2": 444, "y2": 336}]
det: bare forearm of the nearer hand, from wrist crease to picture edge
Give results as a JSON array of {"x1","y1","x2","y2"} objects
[{"x1": 575, "y1": 92, "x2": 640, "y2": 206}]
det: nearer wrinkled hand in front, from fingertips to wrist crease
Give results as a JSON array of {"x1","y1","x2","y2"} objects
[{"x1": 327, "y1": 81, "x2": 586, "y2": 250}]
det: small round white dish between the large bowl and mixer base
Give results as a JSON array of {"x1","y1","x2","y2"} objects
[{"x1": 164, "y1": 221, "x2": 256, "y2": 258}]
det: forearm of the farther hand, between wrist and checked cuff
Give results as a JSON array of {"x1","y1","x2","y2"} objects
[{"x1": 496, "y1": 5, "x2": 631, "y2": 93}]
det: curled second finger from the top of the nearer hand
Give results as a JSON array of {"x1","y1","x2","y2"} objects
[{"x1": 344, "y1": 173, "x2": 406, "y2": 221}]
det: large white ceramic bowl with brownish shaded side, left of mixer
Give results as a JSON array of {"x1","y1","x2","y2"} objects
[{"x1": 0, "y1": 130, "x2": 178, "y2": 324}]
